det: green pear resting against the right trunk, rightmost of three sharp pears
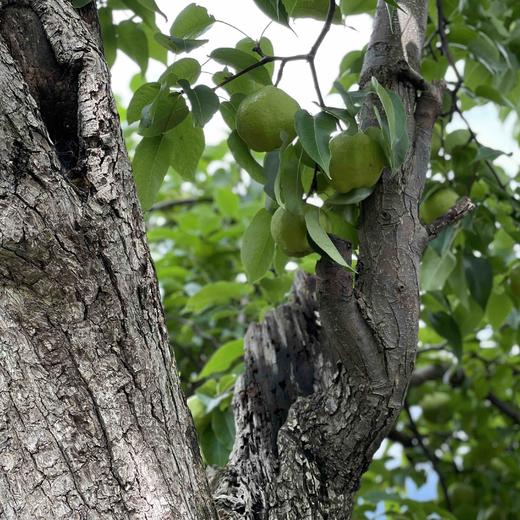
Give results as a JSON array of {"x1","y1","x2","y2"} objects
[{"x1": 329, "y1": 132, "x2": 387, "y2": 193}]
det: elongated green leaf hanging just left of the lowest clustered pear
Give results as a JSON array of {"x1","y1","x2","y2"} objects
[{"x1": 240, "y1": 208, "x2": 274, "y2": 283}]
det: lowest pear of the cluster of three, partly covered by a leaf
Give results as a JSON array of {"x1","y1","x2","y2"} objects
[{"x1": 271, "y1": 208, "x2": 312, "y2": 257}]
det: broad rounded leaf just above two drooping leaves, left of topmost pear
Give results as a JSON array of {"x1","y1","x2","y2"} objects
[{"x1": 139, "y1": 89, "x2": 190, "y2": 137}]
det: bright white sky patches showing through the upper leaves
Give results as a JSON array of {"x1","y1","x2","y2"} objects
[{"x1": 112, "y1": 0, "x2": 520, "y2": 177}]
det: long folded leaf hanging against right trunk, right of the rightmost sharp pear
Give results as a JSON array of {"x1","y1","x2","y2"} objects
[{"x1": 372, "y1": 78, "x2": 409, "y2": 172}]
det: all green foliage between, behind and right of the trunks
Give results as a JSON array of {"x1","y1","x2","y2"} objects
[{"x1": 99, "y1": 0, "x2": 520, "y2": 520}]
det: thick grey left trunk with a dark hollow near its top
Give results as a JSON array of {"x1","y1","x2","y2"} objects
[{"x1": 0, "y1": 0, "x2": 214, "y2": 520}]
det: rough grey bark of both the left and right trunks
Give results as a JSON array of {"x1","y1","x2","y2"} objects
[{"x1": 0, "y1": 0, "x2": 456, "y2": 520}]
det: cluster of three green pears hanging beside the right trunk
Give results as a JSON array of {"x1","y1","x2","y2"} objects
[{"x1": 236, "y1": 86, "x2": 387, "y2": 257}]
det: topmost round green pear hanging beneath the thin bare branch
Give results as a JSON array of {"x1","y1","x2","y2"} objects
[{"x1": 236, "y1": 85, "x2": 300, "y2": 152}]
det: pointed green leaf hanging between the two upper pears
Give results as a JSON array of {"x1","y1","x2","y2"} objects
[{"x1": 295, "y1": 110, "x2": 336, "y2": 177}]
